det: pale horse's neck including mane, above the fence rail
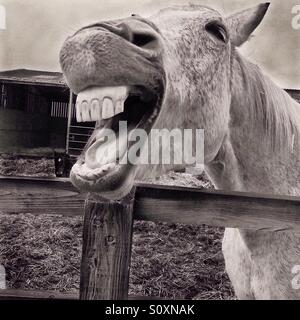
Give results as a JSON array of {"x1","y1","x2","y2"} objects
[{"x1": 207, "y1": 53, "x2": 300, "y2": 195}]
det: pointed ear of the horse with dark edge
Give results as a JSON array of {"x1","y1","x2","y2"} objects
[{"x1": 226, "y1": 2, "x2": 270, "y2": 47}]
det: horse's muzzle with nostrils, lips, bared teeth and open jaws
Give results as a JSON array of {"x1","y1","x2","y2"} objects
[{"x1": 60, "y1": 18, "x2": 165, "y2": 198}]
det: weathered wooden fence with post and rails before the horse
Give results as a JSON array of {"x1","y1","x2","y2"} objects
[{"x1": 0, "y1": 177, "x2": 300, "y2": 299}]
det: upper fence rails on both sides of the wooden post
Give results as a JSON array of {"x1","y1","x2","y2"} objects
[{"x1": 0, "y1": 178, "x2": 300, "y2": 232}]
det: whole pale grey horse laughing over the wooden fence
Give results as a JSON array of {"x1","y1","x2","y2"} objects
[{"x1": 60, "y1": 3, "x2": 300, "y2": 299}]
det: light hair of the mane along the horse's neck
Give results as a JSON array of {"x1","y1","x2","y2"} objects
[{"x1": 232, "y1": 52, "x2": 300, "y2": 153}]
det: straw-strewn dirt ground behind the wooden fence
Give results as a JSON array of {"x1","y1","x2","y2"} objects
[{"x1": 0, "y1": 157, "x2": 234, "y2": 299}]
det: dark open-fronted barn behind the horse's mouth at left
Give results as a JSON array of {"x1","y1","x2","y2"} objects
[{"x1": 0, "y1": 69, "x2": 94, "y2": 157}]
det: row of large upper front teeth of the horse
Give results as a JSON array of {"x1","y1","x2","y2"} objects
[{"x1": 76, "y1": 86, "x2": 129, "y2": 122}]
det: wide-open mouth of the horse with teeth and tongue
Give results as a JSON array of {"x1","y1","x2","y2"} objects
[{"x1": 71, "y1": 86, "x2": 161, "y2": 198}]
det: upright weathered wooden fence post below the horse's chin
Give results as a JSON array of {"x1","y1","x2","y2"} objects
[{"x1": 80, "y1": 190, "x2": 135, "y2": 300}]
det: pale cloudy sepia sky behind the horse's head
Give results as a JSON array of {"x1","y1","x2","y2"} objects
[{"x1": 0, "y1": 0, "x2": 300, "y2": 88}]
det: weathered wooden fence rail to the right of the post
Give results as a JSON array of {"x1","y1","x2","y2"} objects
[{"x1": 134, "y1": 184, "x2": 300, "y2": 233}]
